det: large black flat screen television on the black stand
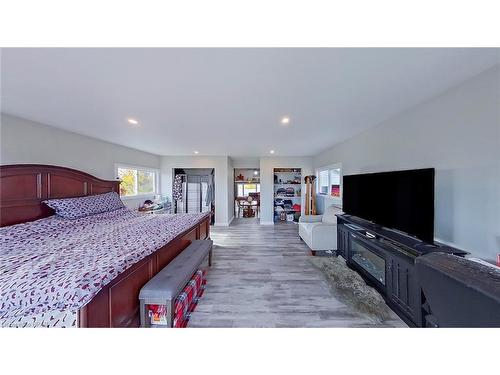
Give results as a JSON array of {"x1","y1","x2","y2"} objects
[{"x1": 342, "y1": 168, "x2": 434, "y2": 243}]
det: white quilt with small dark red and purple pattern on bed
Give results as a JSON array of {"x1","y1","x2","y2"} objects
[{"x1": 0, "y1": 209, "x2": 208, "y2": 327}]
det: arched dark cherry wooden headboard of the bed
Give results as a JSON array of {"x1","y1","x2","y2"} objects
[{"x1": 0, "y1": 164, "x2": 120, "y2": 227}]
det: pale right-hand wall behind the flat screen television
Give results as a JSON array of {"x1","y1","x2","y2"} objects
[{"x1": 314, "y1": 65, "x2": 500, "y2": 260}]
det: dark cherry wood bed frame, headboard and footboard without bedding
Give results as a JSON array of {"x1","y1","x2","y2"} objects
[{"x1": 0, "y1": 164, "x2": 210, "y2": 327}]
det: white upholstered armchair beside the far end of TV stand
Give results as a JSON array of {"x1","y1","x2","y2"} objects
[{"x1": 299, "y1": 206, "x2": 342, "y2": 255}]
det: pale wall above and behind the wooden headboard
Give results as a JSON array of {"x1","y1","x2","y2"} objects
[{"x1": 0, "y1": 113, "x2": 160, "y2": 208}]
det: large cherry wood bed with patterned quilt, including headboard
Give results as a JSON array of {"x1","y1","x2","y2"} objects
[{"x1": 0, "y1": 164, "x2": 210, "y2": 327}]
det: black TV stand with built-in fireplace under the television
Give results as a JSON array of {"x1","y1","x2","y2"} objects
[{"x1": 337, "y1": 215, "x2": 468, "y2": 327}]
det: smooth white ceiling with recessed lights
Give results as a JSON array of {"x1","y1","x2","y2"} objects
[{"x1": 1, "y1": 48, "x2": 500, "y2": 157}]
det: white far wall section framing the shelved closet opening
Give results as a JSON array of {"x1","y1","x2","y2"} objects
[{"x1": 260, "y1": 157, "x2": 314, "y2": 225}]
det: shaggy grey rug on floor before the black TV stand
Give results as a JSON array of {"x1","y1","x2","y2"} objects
[{"x1": 309, "y1": 256, "x2": 399, "y2": 323}]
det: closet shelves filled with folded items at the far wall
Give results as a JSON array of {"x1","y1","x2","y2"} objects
[{"x1": 273, "y1": 168, "x2": 302, "y2": 222}]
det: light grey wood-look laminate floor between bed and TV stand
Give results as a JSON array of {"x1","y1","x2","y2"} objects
[{"x1": 189, "y1": 219, "x2": 406, "y2": 327}]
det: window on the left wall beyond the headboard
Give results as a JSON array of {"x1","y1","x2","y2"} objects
[{"x1": 116, "y1": 165, "x2": 158, "y2": 197}]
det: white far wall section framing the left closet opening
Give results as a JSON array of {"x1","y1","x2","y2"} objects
[{"x1": 161, "y1": 156, "x2": 233, "y2": 226}]
